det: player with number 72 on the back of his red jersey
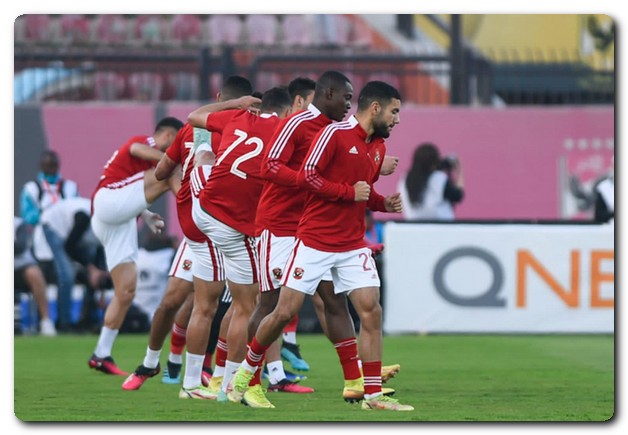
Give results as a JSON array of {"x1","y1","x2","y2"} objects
[{"x1": 182, "y1": 88, "x2": 291, "y2": 406}]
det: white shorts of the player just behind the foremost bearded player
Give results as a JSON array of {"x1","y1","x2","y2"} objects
[{"x1": 257, "y1": 230, "x2": 332, "y2": 293}]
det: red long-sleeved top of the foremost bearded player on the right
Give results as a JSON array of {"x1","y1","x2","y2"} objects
[{"x1": 296, "y1": 116, "x2": 386, "y2": 252}]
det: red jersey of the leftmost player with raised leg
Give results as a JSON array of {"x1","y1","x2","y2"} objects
[{"x1": 96, "y1": 136, "x2": 157, "y2": 191}]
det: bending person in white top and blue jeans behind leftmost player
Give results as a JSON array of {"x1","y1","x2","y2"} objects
[{"x1": 41, "y1": 197, "x2": 109, "y2": 332}]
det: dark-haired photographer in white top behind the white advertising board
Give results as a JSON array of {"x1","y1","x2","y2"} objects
[{"x1": 397, "y1": 143, "x2": 464, "y2": 221}]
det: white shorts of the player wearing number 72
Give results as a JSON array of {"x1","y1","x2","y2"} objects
[{"x1": 192, "y1": 201, "x2": 258, "y2": 284}]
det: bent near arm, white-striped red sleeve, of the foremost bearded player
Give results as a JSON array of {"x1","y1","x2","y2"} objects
[{"x1": 297, "y1": 128, "x2": 356, "y2": 201}]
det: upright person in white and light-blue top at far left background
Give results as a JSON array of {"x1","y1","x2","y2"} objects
[{"x1": 20, "y1": 150, "x2": 78, "y2": 272}]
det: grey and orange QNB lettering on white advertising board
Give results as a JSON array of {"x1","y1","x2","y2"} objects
[{"x1": 432, "y1": 246, "x2": 615, "y2": 308}]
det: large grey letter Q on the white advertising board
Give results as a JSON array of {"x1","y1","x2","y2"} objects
[{"x1": 434, "y1": 247, "x2": 506, "y2": 307}]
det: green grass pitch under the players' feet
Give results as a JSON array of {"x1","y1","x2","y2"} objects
[{"x1": 14, "y1": 334, "x2": 615, "y2": 422}]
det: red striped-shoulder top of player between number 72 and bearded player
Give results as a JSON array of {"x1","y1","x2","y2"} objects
[{"x1": 256, "y1": 104, "x2": 333, "y2": 237}]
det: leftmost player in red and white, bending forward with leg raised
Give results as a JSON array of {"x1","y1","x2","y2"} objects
[{"x1": 88, "y1": 117, "x2": 183, "y2": 375}]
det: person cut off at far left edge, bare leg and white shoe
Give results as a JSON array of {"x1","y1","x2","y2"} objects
[{"x1": 13, "y1": 216, "x2": 57, "y2": 337}]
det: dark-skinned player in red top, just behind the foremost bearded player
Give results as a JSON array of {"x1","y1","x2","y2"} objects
[{"x1": 238, "y1": 71, "x2": 398, "y2": 403}]
